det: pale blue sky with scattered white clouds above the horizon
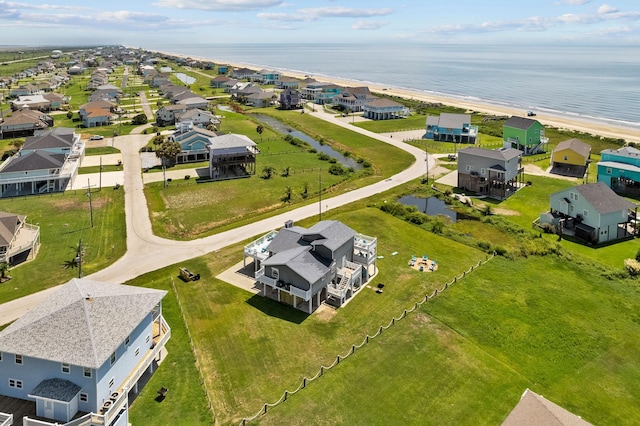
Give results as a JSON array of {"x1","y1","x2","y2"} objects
[{"x1": 0, "y1": 0, "x2": 640, "y2": 49}]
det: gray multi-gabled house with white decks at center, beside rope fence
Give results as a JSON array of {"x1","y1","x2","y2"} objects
[{"x1": 244, "y1": 220, "x2": 377, "y2": 313}]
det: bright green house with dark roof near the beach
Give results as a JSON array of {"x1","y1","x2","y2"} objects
[{"x1": 502, "y1": 116, "x2": 549, "y2": 155}]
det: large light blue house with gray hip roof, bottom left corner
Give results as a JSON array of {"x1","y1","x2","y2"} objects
[{"x1": 0, "y1": 279, "x2": 171, "y2": 426}]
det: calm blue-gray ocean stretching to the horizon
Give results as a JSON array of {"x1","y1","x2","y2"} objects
[{"x1": 154, "y1": 43, "x2": 640, "y2": 131}]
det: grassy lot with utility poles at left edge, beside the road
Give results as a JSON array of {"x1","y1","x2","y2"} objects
[{"x1": 0, "y1": 190, "x2": 126, "y2": 303}]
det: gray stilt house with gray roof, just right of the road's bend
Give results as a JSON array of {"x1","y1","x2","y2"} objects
[{"x1": 458, "y1": 146, "x2": 524, "y2": 199}]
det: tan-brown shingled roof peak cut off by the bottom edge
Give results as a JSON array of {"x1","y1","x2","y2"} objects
[{"x1": 502, "y1": 389, "x2": 591, "y2": 426}]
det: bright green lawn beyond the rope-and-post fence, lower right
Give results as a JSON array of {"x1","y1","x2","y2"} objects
[{"x1": 256, "y1": 257, "x2": 640, "y2": 425}]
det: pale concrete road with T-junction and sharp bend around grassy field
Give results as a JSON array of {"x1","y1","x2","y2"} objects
[{"x1": 0, "y1": 115, "x2": 435, "y2": 325}]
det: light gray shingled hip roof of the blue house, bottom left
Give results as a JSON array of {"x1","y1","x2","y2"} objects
[{"x1": 0, "y1": 278, "x2": 167, "y2": 368}]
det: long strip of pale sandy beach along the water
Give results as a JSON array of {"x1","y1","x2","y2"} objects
[{"x1": 148, "y1": 46, "x2": 640, "y2": 143}]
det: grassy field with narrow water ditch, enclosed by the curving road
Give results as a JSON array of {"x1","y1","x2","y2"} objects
[{"x1": 145, "y1": 110, "x2": 413, "y2": 239}]
